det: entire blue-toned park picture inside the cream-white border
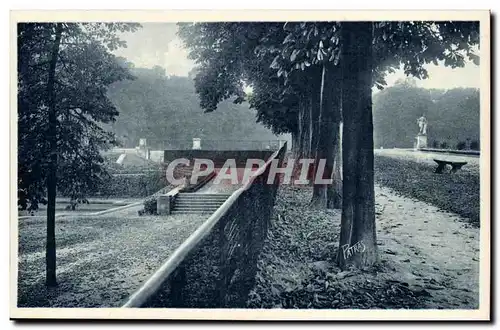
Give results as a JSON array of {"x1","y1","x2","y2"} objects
[{"x1": 13, "y1": 20, "x2": 485, "y2": 310}]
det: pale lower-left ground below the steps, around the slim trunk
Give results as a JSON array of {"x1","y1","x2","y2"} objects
[{"x1": 18, "y1": 205, "x2": 206, "y2": 307}]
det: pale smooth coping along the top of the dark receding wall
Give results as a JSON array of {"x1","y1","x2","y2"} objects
[{"x1": 122, "y1": 143, "x2": 286, "y2": 308}]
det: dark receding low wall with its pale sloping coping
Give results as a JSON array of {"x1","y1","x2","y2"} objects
[{"x1": 123, "y1": 144, "x2": 286, "y2": 308}]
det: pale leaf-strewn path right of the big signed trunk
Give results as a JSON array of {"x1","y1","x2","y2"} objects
[{"x1": 376, "y1": 187, "x2": 479, "y2": 308}]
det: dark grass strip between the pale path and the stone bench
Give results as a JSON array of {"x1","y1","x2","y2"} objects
[{"x1": 375, "y1": 155, "x2": 480, "y2": 226}]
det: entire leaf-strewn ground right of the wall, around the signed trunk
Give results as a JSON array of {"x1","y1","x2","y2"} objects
[{"x1": 247, "y1": 186, "x2": 479, "y2": 309}]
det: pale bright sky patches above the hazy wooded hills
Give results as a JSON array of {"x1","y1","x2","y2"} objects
[{"x1": 114, "y1": 23, "x2": 480, "y2": 89}]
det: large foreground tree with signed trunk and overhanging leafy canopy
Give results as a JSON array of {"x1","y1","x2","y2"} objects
[{"x1": 180, "y1": 21, "x2": 479, "y2": 267}]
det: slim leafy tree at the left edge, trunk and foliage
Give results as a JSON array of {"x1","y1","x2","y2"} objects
[{"x1": 18, "y1": 23, "x2": 138, "y2": 286}]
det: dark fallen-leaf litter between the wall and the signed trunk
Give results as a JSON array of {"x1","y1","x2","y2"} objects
[{"x1": 247, "y1": 186, "x2": 425, "y2": 309}]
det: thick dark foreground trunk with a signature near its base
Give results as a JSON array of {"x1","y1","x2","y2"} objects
[{"x1": 337, "y1": 22, "x2": 377, "y2": 268}]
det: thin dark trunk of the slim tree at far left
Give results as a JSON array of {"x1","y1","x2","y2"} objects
[{"x1": 45, "y1": 23, "x2": 62, "y2": 286}]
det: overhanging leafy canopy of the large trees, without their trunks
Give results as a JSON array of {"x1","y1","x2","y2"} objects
[{"x1": 179, "y1": 21, "x2": 479, "y2": 132}]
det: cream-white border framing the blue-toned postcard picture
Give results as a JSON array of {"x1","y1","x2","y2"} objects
[{"x1": 10, "y1": 10, "x2": 491, "y2": 320}]
